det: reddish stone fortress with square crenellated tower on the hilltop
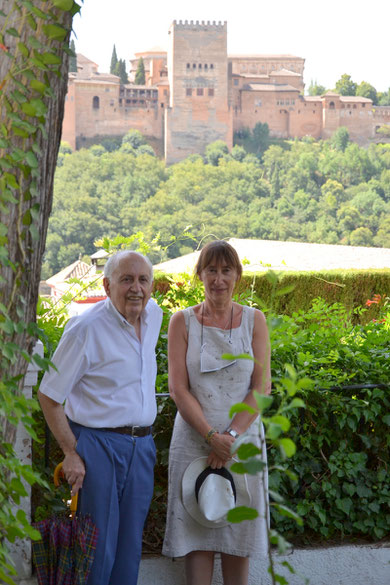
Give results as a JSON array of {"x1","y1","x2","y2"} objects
[{"x1": 62, "y1": 21, "x2": 390, "y2": 164}]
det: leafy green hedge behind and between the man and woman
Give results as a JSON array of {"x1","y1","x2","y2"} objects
[{"x1": 35, "y1": 273, "x2": 390, "y2": 552}]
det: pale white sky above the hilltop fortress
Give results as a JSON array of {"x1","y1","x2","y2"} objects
[{"x1": 73, "y1": 0, "x2": 390, "y2": 93}]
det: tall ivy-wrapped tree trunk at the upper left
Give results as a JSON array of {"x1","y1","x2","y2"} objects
[{"x1": 0, "y1": 0, "x2": 72, "y2": 444}]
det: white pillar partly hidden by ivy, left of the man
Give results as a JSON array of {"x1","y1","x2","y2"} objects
[{"x1": 9, "y1": 341, "x2": 43, "y2": 585}]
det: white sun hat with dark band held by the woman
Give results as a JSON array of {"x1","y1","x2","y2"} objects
[{"x1": 182, "y1": 457, "x2": 251, "y2": 528}]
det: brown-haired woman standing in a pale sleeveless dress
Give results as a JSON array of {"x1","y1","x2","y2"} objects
[{"x1": 163, "y1": 240, "x2": 271, "y2": 585}]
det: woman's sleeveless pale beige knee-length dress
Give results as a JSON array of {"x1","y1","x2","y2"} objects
[{"x1": 162, "y1": 306, "x2": 267, "y2": 557}]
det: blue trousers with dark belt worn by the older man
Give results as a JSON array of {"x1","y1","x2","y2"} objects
[{"x1": 70, "y1": 422, "x2": 156, "y2": 585}]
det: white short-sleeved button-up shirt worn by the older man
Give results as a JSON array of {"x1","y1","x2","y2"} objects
[{"x1": 40, "y1": 298, "x2": 162, "y2": 428}]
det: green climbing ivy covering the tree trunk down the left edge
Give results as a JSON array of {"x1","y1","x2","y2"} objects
[{"x1": 0, "y1": 0, "x2": 80, "y2": 584}]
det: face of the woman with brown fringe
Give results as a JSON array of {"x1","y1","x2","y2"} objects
[{"x1": 200, "y1": 260, "x2": 238, "y2": 302}]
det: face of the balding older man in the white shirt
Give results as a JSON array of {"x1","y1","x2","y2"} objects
[{"x1": 103, "y1": 253, "x2": 153, "y2": 325}]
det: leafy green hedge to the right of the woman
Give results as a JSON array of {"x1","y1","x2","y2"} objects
[{"x1": 271, "y1": 295, "x2": 390, "y2": 543}]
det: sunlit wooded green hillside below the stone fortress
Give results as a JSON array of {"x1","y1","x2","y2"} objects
[{"x1": 42, "y1": 129, "x2": 390, "y2": 278}]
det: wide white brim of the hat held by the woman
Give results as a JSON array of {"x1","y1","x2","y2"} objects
[{"x1": 182, "y1": 457, "x2": 251, "y2": 528}]
